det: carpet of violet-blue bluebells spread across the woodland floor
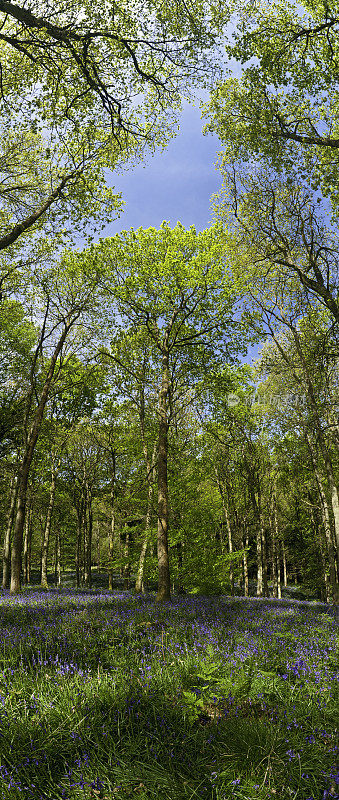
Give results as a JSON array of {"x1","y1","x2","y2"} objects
[{"x1": 0, "y1": 590, "x2": 336, "y2": 800}]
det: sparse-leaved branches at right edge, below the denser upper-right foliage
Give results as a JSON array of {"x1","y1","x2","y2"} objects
[{"x1": 210, "y1": 166, "x2": 339, "y2": 322}]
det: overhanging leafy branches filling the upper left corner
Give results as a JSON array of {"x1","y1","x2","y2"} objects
[{"x1": 0, "y1": 0, "x2": 228, "y2": 255}]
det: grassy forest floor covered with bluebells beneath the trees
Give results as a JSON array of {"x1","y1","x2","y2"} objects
[{"x1": 0, "y1": 590, "x2": 339, "y2": 800}]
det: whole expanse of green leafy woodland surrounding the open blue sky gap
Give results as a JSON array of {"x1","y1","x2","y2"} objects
[{"x1": 0, "y1": 0, "x2": 339, "y2": 602}]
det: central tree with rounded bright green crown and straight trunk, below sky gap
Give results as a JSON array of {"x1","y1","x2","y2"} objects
[{"x1": 95, "y1": 223, "x2": 241, "y2": 601}]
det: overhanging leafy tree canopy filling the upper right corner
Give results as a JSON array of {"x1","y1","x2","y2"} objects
[{"x1": 205, "y1": 0, "x2": 339, "y2": 322}]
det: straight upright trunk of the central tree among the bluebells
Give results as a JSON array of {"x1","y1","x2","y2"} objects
[{"x1": 156, "y1": 351, "x2": 171, "y2": 602}]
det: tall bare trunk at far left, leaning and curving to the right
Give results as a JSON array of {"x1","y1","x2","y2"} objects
[{"x1": 10, "y1": 324, "x2": 70, "y2": 594}]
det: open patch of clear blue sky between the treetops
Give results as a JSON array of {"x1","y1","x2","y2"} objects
[{"x1": 103, "y1": 105, "x2": 221, "y2": 236}]
